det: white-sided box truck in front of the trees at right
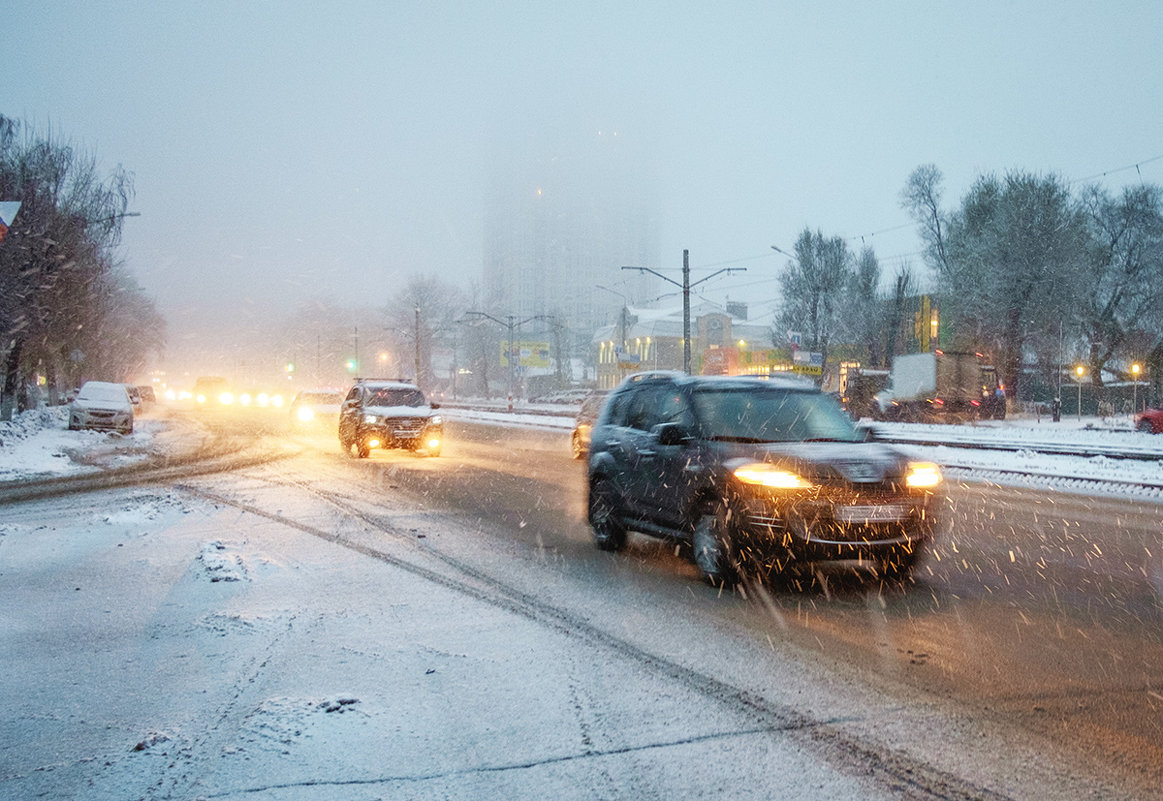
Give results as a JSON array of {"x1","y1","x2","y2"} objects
[{"x1": 873, "y1": 350, "x2": 1006, "y2": 422}]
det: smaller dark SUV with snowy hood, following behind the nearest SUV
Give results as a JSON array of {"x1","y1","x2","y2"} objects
[{"x1": 340, "y1": 378, "x2": 444, "y2": 459}]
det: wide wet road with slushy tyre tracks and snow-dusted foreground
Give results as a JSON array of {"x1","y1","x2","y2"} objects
[{"x1": 0, "y1": 411, "x2": 1163, "y2": 799}]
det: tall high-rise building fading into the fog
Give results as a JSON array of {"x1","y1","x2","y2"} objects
[{"x1": 484, "y1": 131, "x2": 662, "y2": 365}]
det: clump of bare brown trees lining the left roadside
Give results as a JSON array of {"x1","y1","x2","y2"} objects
[{"x1": 0, "y1": 116, "x2": 163, "y2": 416}]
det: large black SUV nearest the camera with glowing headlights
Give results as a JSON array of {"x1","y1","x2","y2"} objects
[{"x1": 588, "y1": 373, "x2": 941, "y2": 584}]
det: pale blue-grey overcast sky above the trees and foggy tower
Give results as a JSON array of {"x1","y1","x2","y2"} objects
[{"x1": 0, "y1": 0, "x2": 1163, "y2": 369}]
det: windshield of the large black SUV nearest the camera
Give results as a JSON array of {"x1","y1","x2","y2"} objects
[{"x1": 693, "y1": 387, "x2": 861, "y2": 442}]
